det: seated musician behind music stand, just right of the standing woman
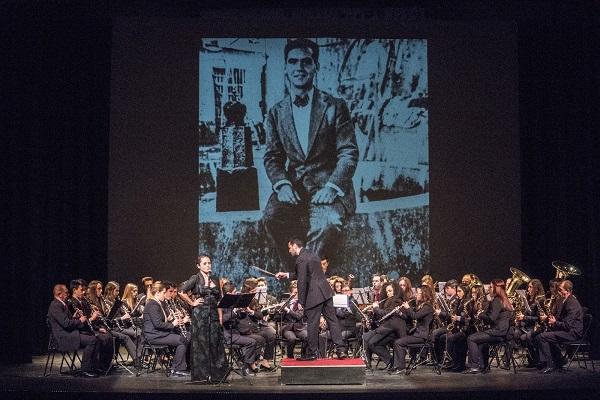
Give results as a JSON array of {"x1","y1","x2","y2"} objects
[{"x1": 220, "y1": 282, "x2": 258, "y2": 375}]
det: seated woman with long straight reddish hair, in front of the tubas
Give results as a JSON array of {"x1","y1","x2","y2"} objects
[{"x1": 465, "y1": 279, "x2": 513, "y2": 374}]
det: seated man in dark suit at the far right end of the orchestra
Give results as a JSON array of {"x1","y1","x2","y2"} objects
[{"x1": 536, "y1": 280, "x2": 583, "y2": 374}]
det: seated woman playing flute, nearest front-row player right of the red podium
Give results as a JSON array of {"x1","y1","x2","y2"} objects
[{"x1": 363, "y1": 282, "x2": 407, "y2": 369}]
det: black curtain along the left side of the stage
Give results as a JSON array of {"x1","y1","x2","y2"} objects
[{"x1": 1, "y1": 15, "x2": 111, "y2": 363}]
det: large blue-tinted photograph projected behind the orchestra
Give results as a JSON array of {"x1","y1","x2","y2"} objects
[{"x1": 198, "y1": 38, "x2": 430, "y2": 285}]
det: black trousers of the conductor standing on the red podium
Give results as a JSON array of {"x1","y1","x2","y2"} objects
[{"x1": 304, "y1": 298, "x2": 344, "y2": 356}]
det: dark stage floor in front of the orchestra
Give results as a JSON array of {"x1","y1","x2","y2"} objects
[{"x1": 0, "y1": 350, "x2": 600, "y2": 400}]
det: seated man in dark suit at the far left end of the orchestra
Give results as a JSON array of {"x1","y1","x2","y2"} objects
[{"x1": 47, "y1": 284, "x2": 99, "y2": 377}]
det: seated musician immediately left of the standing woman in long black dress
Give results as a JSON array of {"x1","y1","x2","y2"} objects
[{"x1": 143, "y1": 281, "x2": 191, "y2": 376}]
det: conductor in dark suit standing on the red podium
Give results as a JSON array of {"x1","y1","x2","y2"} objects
[{"x1": 276, "y1": 238, "x2": 346, "y2": 361}]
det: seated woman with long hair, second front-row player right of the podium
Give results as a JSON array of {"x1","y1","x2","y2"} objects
[{"x1": 390, "y1": 285, "x2": 435, "y2": 375}]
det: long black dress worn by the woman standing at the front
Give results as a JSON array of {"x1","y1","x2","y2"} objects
[{"x1": 180, "y1": 273, "x2": 227, "y2": 382}]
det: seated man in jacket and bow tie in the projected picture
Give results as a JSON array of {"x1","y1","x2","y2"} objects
[{"x1": 264, "y1": 39, "x2": 358, "y2": 271}]
